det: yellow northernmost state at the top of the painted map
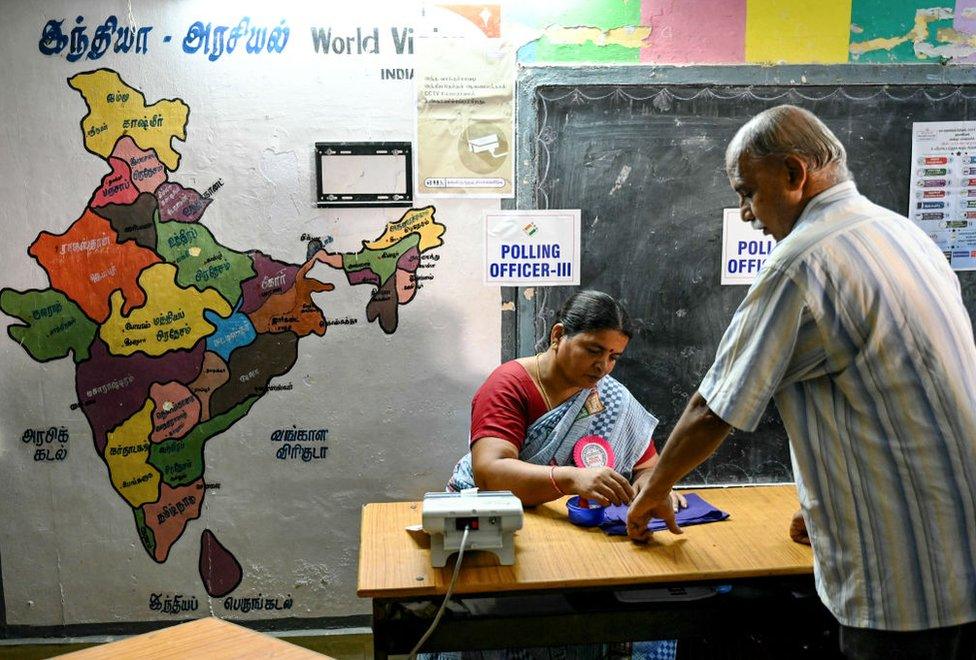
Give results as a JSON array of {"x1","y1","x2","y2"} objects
[{"x1": 68, "y1": 69, "x2": 190, "y2": 171}]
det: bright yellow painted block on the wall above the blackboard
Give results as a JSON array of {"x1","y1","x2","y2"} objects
[{"x1": 745, "y1": 0, "x2": 851, "y2": 64}]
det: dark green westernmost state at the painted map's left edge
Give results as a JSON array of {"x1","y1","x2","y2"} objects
[{"x1": 0, "y1": 289, "x2": 98, "y2": 362}]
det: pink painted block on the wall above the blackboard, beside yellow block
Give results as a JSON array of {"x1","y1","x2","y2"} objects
[{"x1": 641, "y1": 0, "x2": 746, "y2": 64}]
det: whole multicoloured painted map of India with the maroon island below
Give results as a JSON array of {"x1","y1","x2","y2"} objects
[{"x1": 0, "y1": 69, "x2": 445, "y2": 597}]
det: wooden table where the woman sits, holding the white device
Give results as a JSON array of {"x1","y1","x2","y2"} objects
[{"x1": 357, "y1": 485, "x2": 832, "y2": 657}]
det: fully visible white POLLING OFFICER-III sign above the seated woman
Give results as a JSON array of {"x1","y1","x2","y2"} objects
[{"x1": 484, "y1": 209, "x2": 580, "y2": 286}]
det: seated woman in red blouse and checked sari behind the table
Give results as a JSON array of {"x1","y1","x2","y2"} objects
[{"x1": 448, "y1": 291, "x2": 684, "y2": 510}]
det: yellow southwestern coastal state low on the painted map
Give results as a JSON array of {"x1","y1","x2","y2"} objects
[{"x1": 105, "y1": 401, "x2": 160, "y2": 509}]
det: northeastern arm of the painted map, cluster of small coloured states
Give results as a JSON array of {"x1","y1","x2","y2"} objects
[{"x1": 312, "y1": 206, "x2": 447, "y2": 334}]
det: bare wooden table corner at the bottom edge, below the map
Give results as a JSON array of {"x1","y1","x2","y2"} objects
[{"x1": 60, "y1": 618, "x2": 328, "y2": 660}]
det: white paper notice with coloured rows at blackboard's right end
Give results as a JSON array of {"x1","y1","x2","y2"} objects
[{"x1": 908, "y1": 121, "x2": 976, "y2": 270}]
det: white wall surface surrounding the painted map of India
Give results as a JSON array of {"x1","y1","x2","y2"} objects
[{"x1": 0, "y1": 0, "x2": 500, "y2": 626}]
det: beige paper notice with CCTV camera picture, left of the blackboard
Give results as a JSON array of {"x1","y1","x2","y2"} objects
[{"x1": 416, "y1": 36, "x2": 515, "y2": 197}]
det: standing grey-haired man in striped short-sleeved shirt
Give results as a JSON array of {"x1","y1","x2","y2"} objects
[{"x1": 628, "y1": 106, "x2": 976, "y2": 659}]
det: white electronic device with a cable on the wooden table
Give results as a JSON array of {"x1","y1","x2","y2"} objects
[{"x1": 422, "y1": 488, "x2": 522, "y2": 568}]
